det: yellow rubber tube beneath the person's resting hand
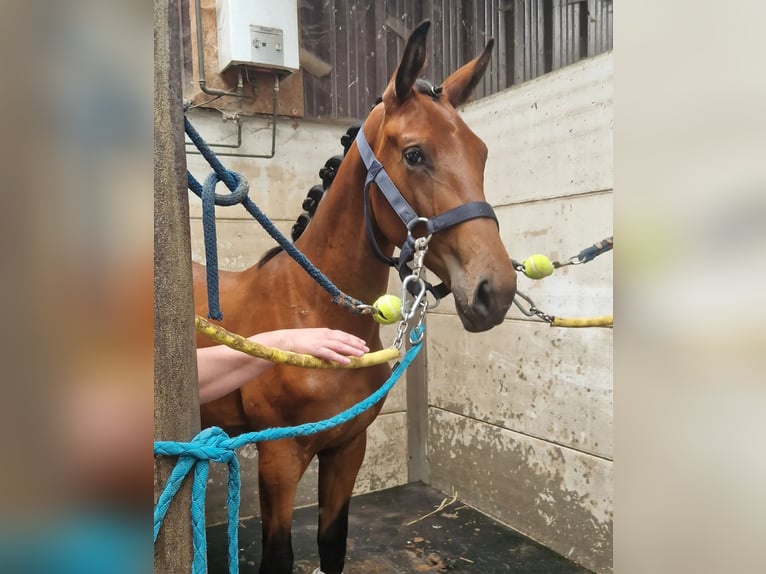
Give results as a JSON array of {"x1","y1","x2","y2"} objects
[{"x1": 194, "y1": 315, "x2": 402, "y2": 369}]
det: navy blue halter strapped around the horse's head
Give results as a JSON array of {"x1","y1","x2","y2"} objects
[{"x1": 356, "y1": 126, "x2": 499, "y2": 299}]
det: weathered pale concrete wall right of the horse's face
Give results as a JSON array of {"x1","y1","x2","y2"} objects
[{"x1": 427, "y1": 54, "x2": 613, "y2": 572}]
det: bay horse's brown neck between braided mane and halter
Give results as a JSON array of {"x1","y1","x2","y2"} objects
[{"x1": 296, "y1": 117, "x2": 394, "y2": 303}]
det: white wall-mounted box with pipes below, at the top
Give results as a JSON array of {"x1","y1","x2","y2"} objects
[{"x1": 216, "y1": 0, "x2": 300, "y2": 75}]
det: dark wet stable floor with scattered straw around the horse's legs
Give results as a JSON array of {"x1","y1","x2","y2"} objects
[{"x1": 208, "y1": 483, "x2": 590, "y2": 574}]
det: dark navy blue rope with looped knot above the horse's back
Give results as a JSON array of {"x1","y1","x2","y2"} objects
[{"x1": 184, "y1": 116, "x2": 365, "y2": 321}]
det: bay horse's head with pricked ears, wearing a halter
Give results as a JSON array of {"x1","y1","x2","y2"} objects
[{"x1": 357, "y1": 21, "x2": 516, "y2": 332}]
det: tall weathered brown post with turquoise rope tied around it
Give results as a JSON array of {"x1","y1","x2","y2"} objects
[{"x1": 154, "y1": 0, "x2": 200, "y2": 574}]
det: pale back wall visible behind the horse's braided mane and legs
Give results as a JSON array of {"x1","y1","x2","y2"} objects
[{"x1": 187, "y1": 112, "x2": 407, "y2": 523}]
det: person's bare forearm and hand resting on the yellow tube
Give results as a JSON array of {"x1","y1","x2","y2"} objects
[{"x1": 197, "y1": 328, "x2": 369, "y2": 404}]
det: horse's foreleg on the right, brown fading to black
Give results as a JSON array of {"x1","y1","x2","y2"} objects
[{"x1": 317, "y1": 431, "x2": 367, "y2": 574}]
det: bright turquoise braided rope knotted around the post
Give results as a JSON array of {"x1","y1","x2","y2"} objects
[{"x1": 154, "y1": 325, "x2": 424, "y2": 574}]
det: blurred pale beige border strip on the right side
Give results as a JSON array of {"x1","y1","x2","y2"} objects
[{"x1": 614, "y1": 0, "x2": 766, "y2": 574}]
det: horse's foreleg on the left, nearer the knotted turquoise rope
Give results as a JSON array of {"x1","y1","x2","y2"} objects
[{"x1": 258, "y1": 439, "x2": 306, "y2": 574}]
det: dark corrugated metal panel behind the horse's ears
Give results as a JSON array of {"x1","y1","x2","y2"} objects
[{"x1": 301, "y1": 0, "x2": 613, "y2": 119}]
